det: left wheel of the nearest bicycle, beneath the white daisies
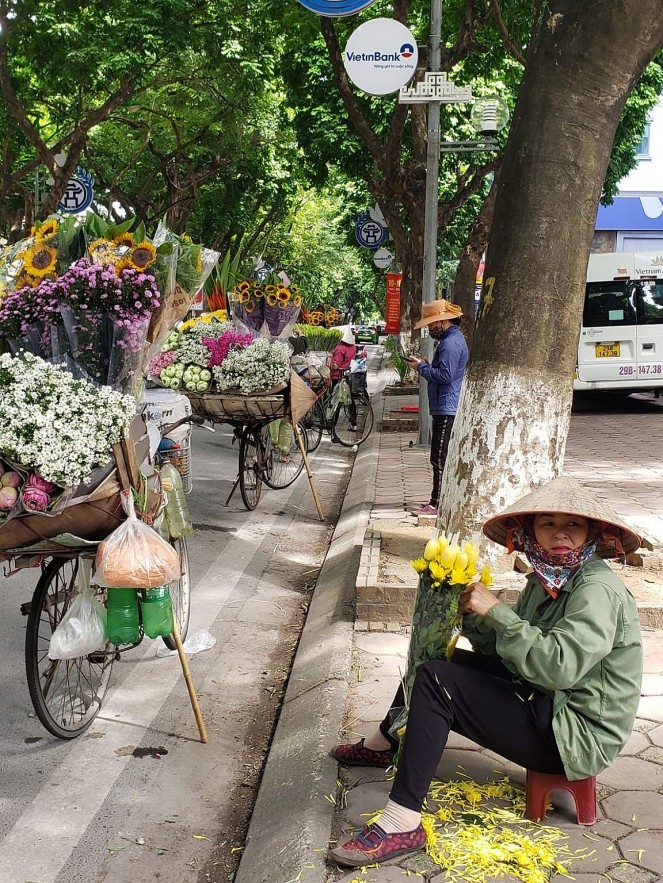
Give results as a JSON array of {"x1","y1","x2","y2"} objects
[{"x1": 25, "y1": 558, "x2": 115, "y2": 739}]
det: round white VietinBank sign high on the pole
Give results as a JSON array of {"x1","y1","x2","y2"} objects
[{"x1": 343, "y1": 18, "x2": 419, "y2": 95}]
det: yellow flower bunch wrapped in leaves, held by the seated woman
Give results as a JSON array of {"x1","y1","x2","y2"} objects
[{"x1": 391, "y1": 534, "x2": 493, "y2": 738}]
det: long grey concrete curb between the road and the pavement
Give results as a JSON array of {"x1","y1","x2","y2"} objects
[{"x1": 234, "y1": 395, "x2": 383, "y2": 883}]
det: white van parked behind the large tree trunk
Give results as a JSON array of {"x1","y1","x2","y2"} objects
[{"x1": 573, "y1": 252, "x2": 663, "y2": 392}]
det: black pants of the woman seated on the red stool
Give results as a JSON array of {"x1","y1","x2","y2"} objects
[{"x1": 380, "y1": 650, "x2": 564, "y2": 812}]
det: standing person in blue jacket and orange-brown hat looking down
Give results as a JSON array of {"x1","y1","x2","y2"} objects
[{"x1": 407, "y1": 299, "x2": 468, "y2": 515}]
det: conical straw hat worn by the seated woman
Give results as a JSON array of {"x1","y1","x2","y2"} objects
[{"x1": 483, "y1": 475, "x2": 640, "y2": 558}]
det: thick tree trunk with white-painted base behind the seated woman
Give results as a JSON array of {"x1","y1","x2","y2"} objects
[{"x1": 439, "y1": 0, "x2": 663, "y2": 538}]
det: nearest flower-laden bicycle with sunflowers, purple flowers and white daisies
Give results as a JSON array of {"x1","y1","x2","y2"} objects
[{"x1": 0, "y1": 216, "x2": 218, "y2": 741}]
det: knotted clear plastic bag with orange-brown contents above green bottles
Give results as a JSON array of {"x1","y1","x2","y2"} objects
[{"x1": 95, "y1": 491, "x2": 180, "y2": 589}]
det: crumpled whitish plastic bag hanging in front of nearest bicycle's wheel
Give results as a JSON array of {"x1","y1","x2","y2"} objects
[{"x1": 48, "y1": 562, "x2": 108, "y2": 659}]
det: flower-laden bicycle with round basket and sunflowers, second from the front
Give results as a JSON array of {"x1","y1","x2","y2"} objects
[{"x1": 149, "y1": 274, "x2": 323, "y2": 520}]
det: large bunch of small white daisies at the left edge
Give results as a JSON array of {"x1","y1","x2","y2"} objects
[{"x1": 0, "y1": 353, "x2": 136, "y2": 496}]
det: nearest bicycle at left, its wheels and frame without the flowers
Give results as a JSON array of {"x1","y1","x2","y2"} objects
[{"x1": 16, "y1": 417, "x2": 202, "y2": 739}]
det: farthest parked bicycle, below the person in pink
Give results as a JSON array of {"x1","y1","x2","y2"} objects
[{"x1": 303, "y1": 372, "x2": 375, "y2": 451}]
